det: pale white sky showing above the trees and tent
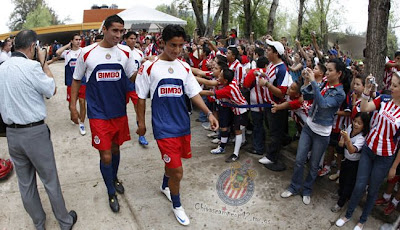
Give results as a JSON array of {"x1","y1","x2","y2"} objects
[{"x1": 0, "y1": 0, "x2": 400, "y2": 43}]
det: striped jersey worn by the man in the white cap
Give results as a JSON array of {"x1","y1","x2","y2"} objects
[{"x1": 264, "y1": 62, "x2": 293, "y2": 104}]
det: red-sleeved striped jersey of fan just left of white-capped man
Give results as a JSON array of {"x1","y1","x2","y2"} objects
[{"x1": 243, "y1": 68, "x2": 266, "y2": 112}]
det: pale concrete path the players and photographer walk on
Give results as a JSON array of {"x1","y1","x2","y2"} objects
[{"x1": 0, "y1": 62, "x2": 390, "y2": 230}]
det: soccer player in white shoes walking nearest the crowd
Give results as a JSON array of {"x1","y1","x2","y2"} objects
[{"x1": 135, "y1": 25, "x2": 218, "y2": 225}]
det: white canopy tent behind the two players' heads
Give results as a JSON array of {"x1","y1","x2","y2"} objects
[{"x1": 118, "y1": 6, "x2": 186, "y2": 32}]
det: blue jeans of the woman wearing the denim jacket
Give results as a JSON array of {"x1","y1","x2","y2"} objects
[{"x1": 288, "y1": 124, "x2": 329, "y2": 196}]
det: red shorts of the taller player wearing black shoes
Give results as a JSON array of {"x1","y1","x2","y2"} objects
[{"x1": 89, "y1": 116, "x2": 131, "y2": 150}]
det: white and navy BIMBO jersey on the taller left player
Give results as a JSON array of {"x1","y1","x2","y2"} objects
[{"x1": 73, "y1": 43, "x2": 136, "y2": 120}]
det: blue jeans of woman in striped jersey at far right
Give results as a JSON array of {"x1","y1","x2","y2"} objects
[{"x1": 346, "y1": 145, "x2": 395, "y2": 224}]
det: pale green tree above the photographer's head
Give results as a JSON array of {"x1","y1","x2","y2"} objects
[{"x1": 22, "y1": 5, "x2": 52, "y2": 29}]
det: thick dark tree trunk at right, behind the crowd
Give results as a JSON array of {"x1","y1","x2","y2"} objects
[{"x1": 365, "y1": 0, "x2": 390, "y2": 89}]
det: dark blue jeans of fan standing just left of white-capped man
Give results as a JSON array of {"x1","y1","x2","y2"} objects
[{"x1": 251, "y1": 111, "x2": 265, "y2": 153}]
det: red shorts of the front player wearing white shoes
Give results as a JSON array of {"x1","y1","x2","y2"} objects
[{"x1": 157, "y1": 134, "x2": 192, "y2": 169}]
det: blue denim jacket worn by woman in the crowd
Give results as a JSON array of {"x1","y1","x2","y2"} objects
[{"x1": 301, "y1": 81, "x2": 346, "y2": 126}]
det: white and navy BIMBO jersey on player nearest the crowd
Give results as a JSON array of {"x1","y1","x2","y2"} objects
[{"x1": 135, "y1": 59, "x2": 201, "y2": 140}]
